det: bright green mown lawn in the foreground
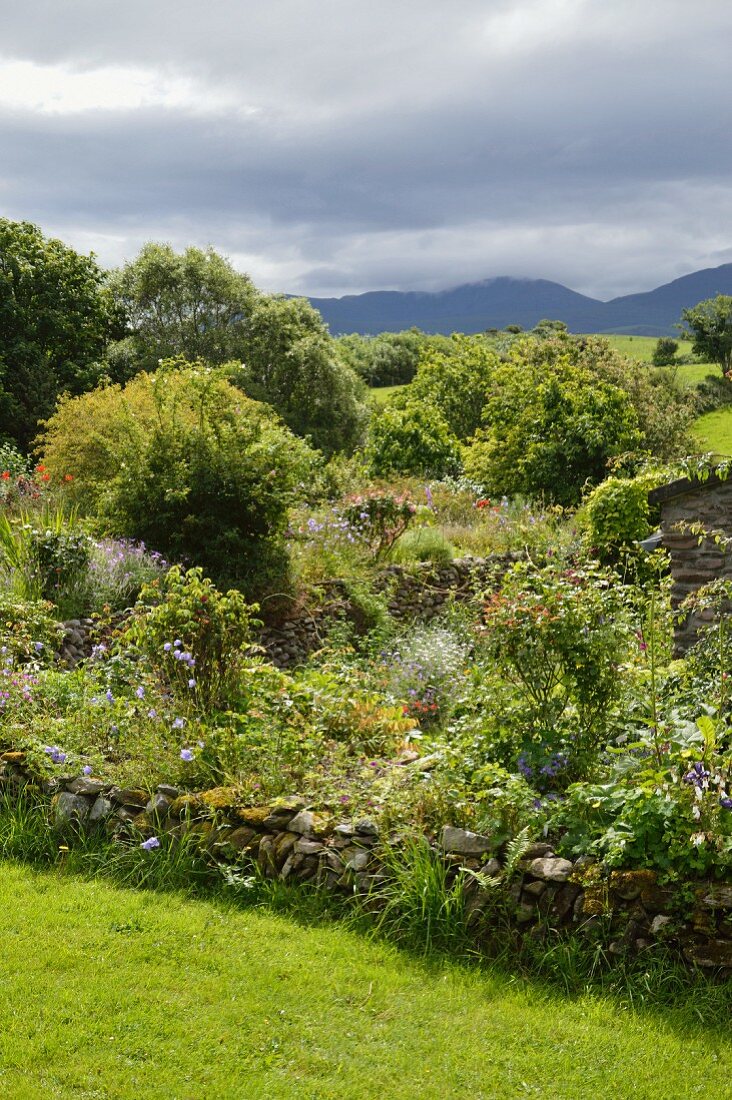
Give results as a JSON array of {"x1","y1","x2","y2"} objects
[{"x1": 0, "y1": 864, "x2": 732, "y2": 1100}]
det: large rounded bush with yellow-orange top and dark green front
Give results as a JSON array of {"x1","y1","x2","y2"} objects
[{"x1": 39, "y1": 360, "x2": 314, "y2": 593}]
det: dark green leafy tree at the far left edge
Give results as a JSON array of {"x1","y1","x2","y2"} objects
[{"x1": 0, "y1": 219, "x2": 116, "y2": 448}]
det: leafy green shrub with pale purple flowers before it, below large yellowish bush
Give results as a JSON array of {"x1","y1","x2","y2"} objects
[{"x1": 120, "y1": 565, "x2": 258, "y2": 711}]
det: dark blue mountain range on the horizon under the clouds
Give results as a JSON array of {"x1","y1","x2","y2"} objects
[{"x1": 310, "y1": 264, "x2": 732, "y2": 337}]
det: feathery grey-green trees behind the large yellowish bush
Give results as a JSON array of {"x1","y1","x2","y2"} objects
[{"x1": 108, "y1": 243, "x2": 365, "y2": 453}]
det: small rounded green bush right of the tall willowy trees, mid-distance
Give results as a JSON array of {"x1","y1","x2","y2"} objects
[{"x1": 365, "y1": 400, "x2": 460, "y2": 477}]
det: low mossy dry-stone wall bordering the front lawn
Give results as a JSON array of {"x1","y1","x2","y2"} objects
[{"x1": 0, "y1": 752, "x2": 732, "y2": 978}]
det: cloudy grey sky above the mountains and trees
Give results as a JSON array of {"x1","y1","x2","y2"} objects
[{"x1": 0, "y1": 0, "x2": 732, "y2": 298}]
